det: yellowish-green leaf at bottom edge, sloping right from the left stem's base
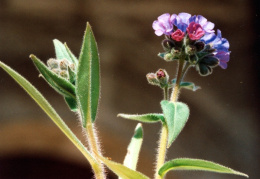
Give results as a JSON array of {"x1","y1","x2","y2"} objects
[{"x1": 99, "y1": 156, "x2": 149, "y2": 179}]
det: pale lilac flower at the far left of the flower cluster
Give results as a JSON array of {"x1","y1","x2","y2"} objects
[{"x1": 153, "y1": 13, "x2": 173, "y2": 36}]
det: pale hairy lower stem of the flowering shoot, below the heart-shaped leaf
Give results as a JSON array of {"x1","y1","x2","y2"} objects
[{"x1": 154, "y1": 124, "x2": 168, "y2": 179}]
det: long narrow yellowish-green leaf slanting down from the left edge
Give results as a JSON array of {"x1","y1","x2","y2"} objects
[{"x1": 0, "y1": 62, "x2": 97, "y2": 165}]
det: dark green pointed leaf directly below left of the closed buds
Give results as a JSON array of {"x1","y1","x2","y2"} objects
[{"x1": 30, "y1": 55, "x2": 76, "y2": 99}]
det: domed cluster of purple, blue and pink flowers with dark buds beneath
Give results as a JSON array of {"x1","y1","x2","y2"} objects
[{"x1": 153, "y1": 13, "x2": 230, "y2": 76}]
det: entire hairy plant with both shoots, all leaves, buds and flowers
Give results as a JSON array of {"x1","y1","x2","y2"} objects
[{"x1": 0, "y1": 13, "x2": 248, "y2": 179}]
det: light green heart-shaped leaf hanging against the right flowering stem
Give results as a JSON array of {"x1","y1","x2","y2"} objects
[{"x1": 161, "y1": 100, "x2": 190, "y2": 148}]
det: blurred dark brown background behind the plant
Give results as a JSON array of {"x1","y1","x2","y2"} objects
[{"x1": 0, "y1": 0, "x2": 260, "y2": 179}]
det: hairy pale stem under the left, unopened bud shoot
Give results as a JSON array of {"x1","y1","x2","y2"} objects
[{"x1": 86, "y1": 122, "x2": 106, "y2": 179}]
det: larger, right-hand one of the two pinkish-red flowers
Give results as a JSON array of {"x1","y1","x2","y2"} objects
[{"x1": 187, "y1": 22, "x2": 205, "y2": 40}]
